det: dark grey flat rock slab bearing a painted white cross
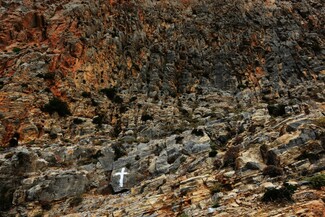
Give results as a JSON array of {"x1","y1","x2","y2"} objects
[{"x1": 111, "y1": 167, "x2": 135, "y2": 192}]
